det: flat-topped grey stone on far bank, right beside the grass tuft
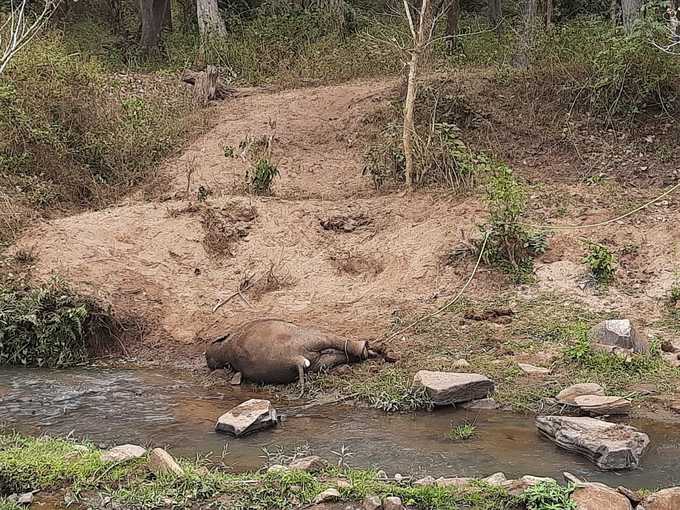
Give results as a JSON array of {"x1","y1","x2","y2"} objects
[{"x1": 413, "y1": 370, "x2": 494, "y2": 406}]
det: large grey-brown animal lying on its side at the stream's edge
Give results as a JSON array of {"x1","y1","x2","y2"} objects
[{"x1": 205, "y1": 319, "x2": 372, "y2": 392}]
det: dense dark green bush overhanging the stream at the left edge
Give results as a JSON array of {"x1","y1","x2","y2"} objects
[{"x1": 0, "y1": 279, "x2": 117, "y2": 367}]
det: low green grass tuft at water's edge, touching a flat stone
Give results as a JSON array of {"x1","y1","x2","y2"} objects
[{"x1": 350, "y1": 368, "x2": 432, "y2": 413}]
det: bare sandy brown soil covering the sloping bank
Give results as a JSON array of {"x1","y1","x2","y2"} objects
[{"x1": 11, "y1": 78, "x2": 680, "y2": 382}]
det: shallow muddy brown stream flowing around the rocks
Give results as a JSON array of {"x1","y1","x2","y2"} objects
[{"x1": 0, "y1": 369, "x2": 680, "y2": 488}]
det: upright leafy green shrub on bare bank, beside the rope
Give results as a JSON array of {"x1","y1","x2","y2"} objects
[{"x1": 477, "y1": 164, "x2": 548, "y2": 282}]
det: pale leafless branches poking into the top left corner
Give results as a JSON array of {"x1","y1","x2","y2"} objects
[{"x1": 0, "y1": 0, "x2": 59, "y2": 74}]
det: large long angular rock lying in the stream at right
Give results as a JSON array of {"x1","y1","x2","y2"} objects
[{"x1": 536, "y1": 416, "x2": 649, "y2": 471}]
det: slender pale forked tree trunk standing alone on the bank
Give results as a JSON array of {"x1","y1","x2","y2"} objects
[{"x1": 403, "y1": 0, "x2": 433, "y2": 191}]
